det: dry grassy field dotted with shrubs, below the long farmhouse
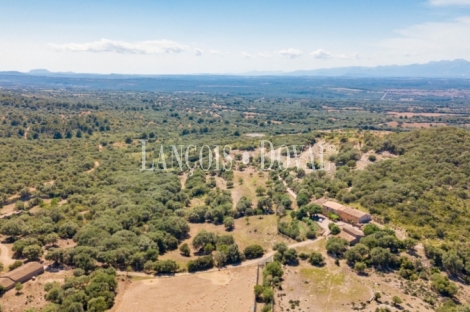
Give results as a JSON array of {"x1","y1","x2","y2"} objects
[{"x1": 275, "y1": 239, "x2": 458, "y2": 312}]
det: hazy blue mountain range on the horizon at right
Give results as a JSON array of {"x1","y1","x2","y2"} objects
[{"x1": 283, "y1": 59, "x2": 470, "y2": 78}]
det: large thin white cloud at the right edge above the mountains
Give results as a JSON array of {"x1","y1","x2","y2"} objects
[{"x1": 379, "y1": 17, "x2": 470, "y2": 61}]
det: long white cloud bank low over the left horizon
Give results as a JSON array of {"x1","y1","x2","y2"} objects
[{"x1": 50, "y1": 39, "x2": 187, "y2": 54}]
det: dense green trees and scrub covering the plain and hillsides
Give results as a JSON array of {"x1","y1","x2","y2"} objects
[{"x1": 0, "y1": 89, "x2": 470, "y2": 311}]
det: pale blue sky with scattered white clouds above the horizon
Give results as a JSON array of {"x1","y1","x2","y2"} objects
[{"x1": 0, "y1": 0, "x2": 470, "y2": 74}]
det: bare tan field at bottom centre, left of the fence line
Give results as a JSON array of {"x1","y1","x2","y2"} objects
[{"x1": 111, "y1": 266, "x2": 256, "y2": 312}]
